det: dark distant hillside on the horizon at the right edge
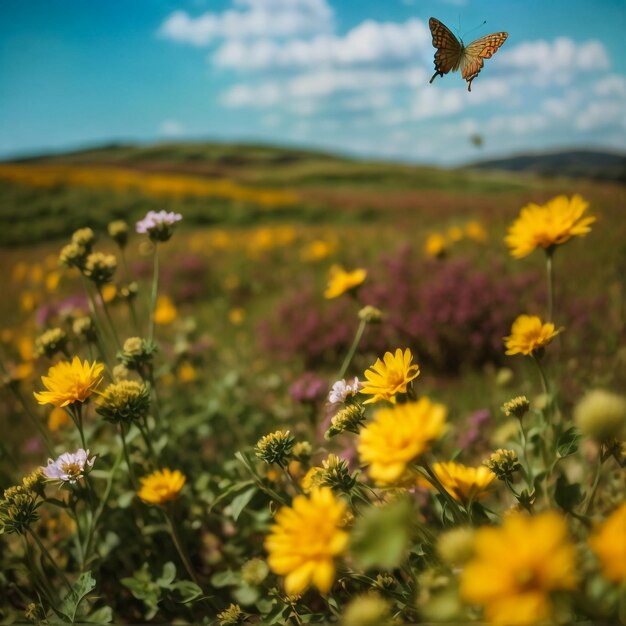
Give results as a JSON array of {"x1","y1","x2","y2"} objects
[{"x1": 466, "y1": 150, "x2": 626, "y2": 183}]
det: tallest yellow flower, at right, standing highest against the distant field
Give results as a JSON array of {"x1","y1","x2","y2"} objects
[{"x1": 504, "y1": 195, "x2": 596, "y2": 259}]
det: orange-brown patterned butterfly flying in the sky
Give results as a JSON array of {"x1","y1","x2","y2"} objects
[{"x1": 428, "y1": 17, "x2": 509, "y2": 91}]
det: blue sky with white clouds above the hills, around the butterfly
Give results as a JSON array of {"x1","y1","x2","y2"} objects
[{"x1": 0, "y1": 0, "x2": 626, "y2": 163}]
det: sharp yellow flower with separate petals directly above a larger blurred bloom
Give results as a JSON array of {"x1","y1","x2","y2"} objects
[{"x1": 361, "y1": 348, "x2": 420, "y2": 404}]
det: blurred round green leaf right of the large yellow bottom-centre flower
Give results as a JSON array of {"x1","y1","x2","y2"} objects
[{"x1": 351, "y1": 498, "x2": 414, "y2": 569}]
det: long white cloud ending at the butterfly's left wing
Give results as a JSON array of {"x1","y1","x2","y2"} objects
[{"x1": 212, "y1": 19, "x2": 430, "y2": 70}]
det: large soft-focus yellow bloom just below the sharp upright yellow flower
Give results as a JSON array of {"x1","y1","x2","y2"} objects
[{"x1": 357, "y1": 398, "x2": 447, "y2": 485}]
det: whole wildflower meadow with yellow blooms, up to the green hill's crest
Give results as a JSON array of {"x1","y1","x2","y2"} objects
[{"x1": 0, "y1": 144, "x2": 626, "y2": 626}]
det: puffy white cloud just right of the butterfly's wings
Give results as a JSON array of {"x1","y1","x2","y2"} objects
[{"x1": 499, "y1": 37, "x2": 609, "y2": 85}]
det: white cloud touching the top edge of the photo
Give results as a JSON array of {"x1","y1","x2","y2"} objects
[{"x1": 158, "y1": 0, "x2": 333, "y2": 46}]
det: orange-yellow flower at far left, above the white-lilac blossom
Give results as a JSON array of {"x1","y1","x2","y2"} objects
[{"x1": 33, "y1": 356, "x2": 104, "y2": 407}]
